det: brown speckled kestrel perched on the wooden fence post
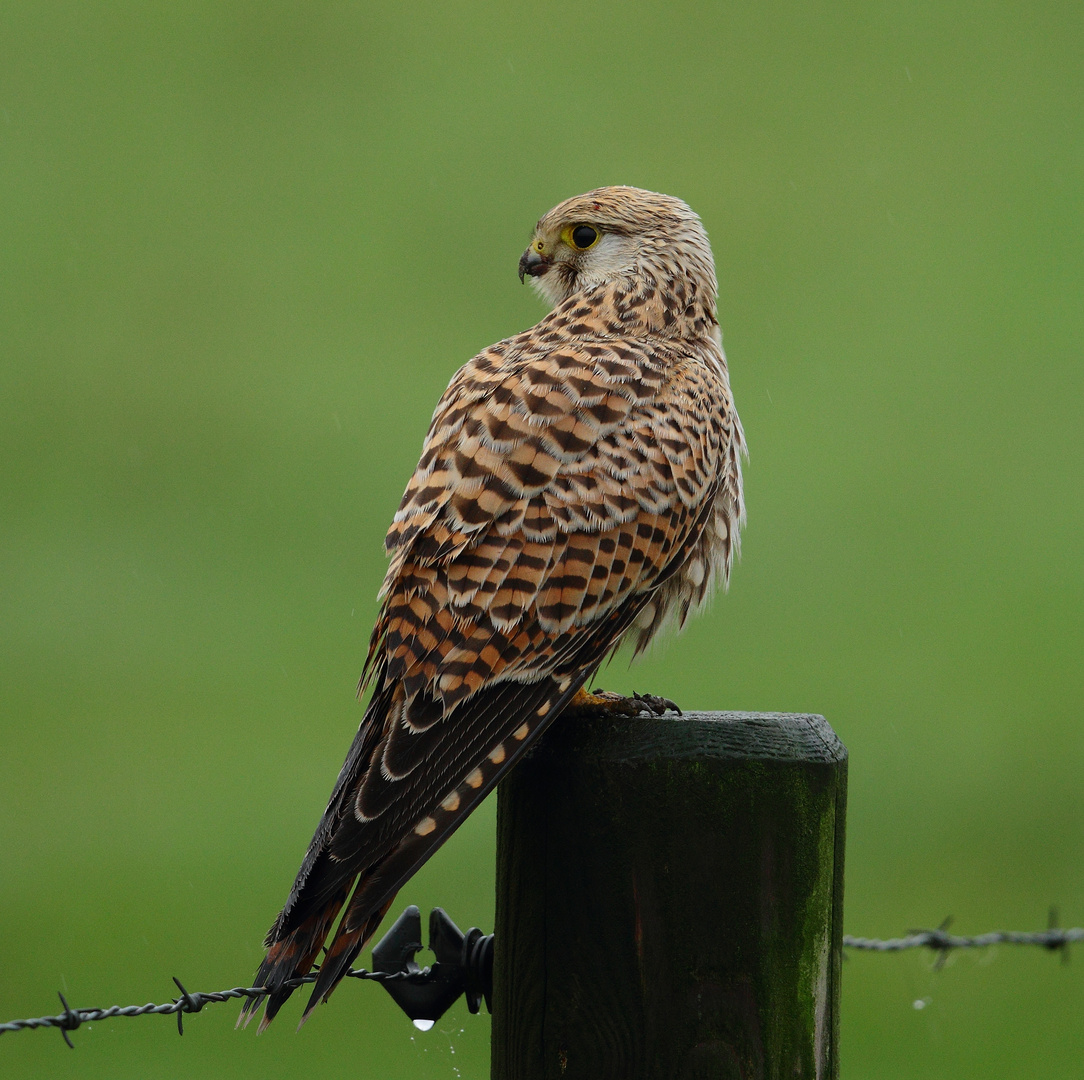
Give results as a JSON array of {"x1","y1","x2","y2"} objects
[{"x1": 238, "y1": 187, "x2": 746, "y2": 1031}]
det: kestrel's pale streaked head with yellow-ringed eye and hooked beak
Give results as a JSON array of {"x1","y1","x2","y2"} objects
[{"x1": 519, "y1": 187, "x2": 717, "y2": 306}]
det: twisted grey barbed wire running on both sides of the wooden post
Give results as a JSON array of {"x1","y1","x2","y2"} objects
[{"x1": 0, "y1": 911, "x2": 1084, "y2": 1049}]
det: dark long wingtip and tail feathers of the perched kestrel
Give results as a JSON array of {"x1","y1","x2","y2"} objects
[{"x1": 237, "y1": 604, "x2": 637, "y2": 1031}]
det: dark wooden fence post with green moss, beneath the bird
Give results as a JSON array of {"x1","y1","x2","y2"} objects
[{"x1": 491, "y1": 712, "x2": 847, "y2": 1080}]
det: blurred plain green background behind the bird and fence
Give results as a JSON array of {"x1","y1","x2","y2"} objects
[{"x1": 0, "y1": 0, "x2": 1084, "y2": 1080}]
